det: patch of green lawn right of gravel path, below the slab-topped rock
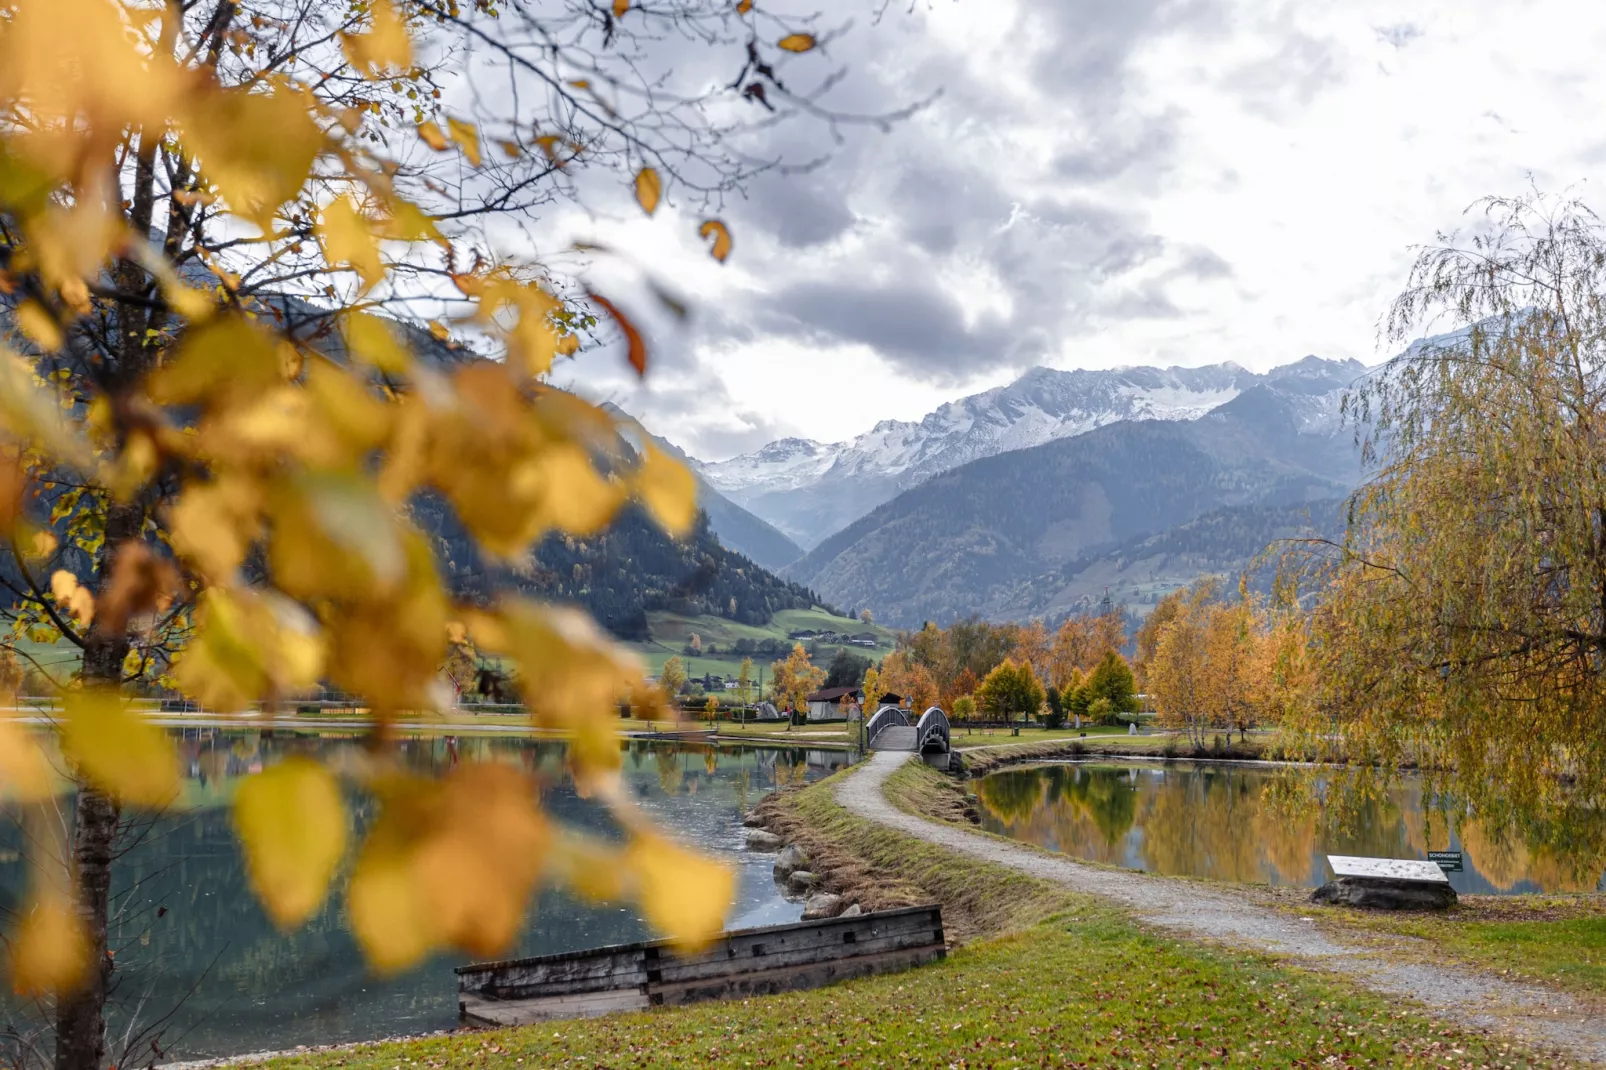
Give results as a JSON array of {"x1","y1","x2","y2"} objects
[{"x1": 1296, "y1": 895, "x2": 1606, "y2": 998}]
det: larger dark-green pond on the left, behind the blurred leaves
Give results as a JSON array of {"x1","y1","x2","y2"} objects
[{"x1": 0, "y1": 728, "x2": 851, "y2": 1065}]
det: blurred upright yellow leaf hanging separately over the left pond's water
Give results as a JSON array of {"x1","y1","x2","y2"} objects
[{"x1": 234, "y1": 757, "x2": 347, "y2": 929}]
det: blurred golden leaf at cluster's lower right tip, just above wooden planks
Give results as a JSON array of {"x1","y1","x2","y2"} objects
[{"x1": 625, "y1": 832, "x2": 736, "y2": 951}]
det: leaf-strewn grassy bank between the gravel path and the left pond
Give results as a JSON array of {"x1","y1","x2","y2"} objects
[{"x1": 267, "y1": 767, "x2": 1558, "y2": 1070}]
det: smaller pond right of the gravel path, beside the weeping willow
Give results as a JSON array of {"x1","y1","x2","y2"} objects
[{"x1": 976, "y1": 762, "x2": 1603, "y2": 895}]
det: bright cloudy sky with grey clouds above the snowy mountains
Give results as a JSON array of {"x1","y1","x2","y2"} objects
[{"x1": 536, "y1": 0, "x2": 1606, "y2": 459}]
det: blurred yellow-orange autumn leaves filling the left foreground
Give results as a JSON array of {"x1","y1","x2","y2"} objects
[{"x1": 0, "y1": 0, "x2": 738, "y2": 993}]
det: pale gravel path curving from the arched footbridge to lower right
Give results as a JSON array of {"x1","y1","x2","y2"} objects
[{"x1": 837, "y1": 750, "x2": 1606, "y2": 1065}]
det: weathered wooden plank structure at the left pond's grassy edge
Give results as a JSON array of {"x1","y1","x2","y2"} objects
[{"x1": 456, "y1": 905, "x2": 944, "y2": 1027}]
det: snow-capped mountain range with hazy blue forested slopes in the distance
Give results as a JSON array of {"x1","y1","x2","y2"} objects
[{"x1": 661, "y1": 357, "x2": 1367, "y2": 627}]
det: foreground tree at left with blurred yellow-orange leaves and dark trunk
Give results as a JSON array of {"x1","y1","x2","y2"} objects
[{"x1": 0, "y1": 0, "x2": 841, "y2": 1067}]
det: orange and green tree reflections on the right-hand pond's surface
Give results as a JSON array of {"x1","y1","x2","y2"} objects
[{"x1": 976, "y1": 765, "x2": 1606, "y2": 892}]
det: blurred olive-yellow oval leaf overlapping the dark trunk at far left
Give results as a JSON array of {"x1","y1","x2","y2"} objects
[{"x1": 61, "y1": 689, "x2": 180, "y2": 808}]
